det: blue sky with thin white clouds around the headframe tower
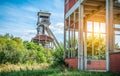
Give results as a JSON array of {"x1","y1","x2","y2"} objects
[{"x1": 0, "y1": 0, "x2": 64, "y2": 42}]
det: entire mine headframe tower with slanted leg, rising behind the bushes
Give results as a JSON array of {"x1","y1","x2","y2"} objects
[{"x1": 32, "y1": 11, "x2": 59, "y2": 48}]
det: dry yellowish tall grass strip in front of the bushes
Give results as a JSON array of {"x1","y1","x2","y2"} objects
[{"x1": 0, "y1": 63, "x2": 49, "y2": 72}]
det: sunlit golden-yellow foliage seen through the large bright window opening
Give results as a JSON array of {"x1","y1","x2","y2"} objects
[{"x1": 87, "y1": 36, "x2": 106, "y2": 59}]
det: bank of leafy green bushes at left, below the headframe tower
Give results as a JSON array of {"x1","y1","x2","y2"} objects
[{"x1": 0, "y1": 34, "x2": 53, "y2": 64}]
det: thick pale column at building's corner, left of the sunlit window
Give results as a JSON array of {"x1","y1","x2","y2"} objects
[{"x1": 78, "y1": 5, "x2": 84, "y2": 70}]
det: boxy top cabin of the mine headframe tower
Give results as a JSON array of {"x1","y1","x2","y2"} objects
[{"x1": 37, "y1": 11, "x2": 51, "y2": 26}]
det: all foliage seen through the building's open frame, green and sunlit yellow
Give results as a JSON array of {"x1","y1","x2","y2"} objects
[{"x1": 67, "y1": 36, "x2": 106, "y2": 59}]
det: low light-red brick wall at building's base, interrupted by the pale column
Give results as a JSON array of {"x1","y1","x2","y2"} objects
[{"x1": 65, "y1": 58, "x2": 106, "y2": 70}]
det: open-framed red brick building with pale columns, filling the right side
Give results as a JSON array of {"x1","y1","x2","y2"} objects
[{"x1": 64, "y1": 0, "x2": 120, "y2": 72}]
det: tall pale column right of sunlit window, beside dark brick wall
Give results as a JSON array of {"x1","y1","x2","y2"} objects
[{"x1": 106, "y1": 0, "x2": 114, "y2": 71}]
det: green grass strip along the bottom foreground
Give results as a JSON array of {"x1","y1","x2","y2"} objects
[{"x1": 0, "y1": 65, "x2": 120, "y2": 76}]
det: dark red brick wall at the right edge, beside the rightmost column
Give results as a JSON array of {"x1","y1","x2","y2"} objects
[{"x1": 110, "y1": 53, "x2": 120, "y2": 72}]
